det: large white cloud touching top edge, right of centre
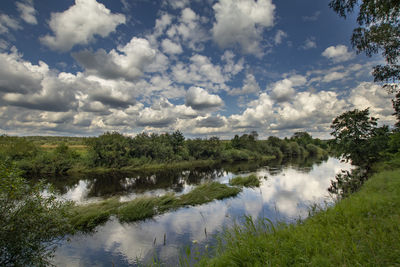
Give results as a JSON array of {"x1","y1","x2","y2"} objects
[{"x1": 212, "y1": 0, "x2": 275, "y2": 54}]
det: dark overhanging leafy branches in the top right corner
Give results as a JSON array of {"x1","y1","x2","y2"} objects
[{"x1": 329, "y1": 0, "x2": 400, "y2": 89}]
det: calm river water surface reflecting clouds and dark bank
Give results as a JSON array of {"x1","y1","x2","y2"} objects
[{"x1": 54, "y1": 158, "x2": 350, "y2": 266}]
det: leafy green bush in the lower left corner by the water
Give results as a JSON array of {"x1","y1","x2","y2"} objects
[{"x1": 0, "y1": 163, "x2": 72, "y2": 266}]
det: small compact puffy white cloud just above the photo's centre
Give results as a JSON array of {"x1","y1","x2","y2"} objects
[{"x1": 185, "y1": 87, "x2": 224, "y2": 110}]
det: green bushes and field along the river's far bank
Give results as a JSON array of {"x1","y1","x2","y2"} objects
[{"x1": 0, "y1": 131, "x2": 329, "y2": 177}]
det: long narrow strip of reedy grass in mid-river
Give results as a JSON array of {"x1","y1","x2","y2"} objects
[{"x1": 71, "y1": 182, "x2": 241, "y2": 231}]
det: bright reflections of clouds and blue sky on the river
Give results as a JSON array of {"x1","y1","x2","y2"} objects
[{"x1": 54, "y1": 158, "x2": 350, "y2": 266}]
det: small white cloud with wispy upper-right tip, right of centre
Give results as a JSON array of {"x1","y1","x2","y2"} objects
[{"x1": 270, "y1": 75, "x2": 307, "y2": 102}]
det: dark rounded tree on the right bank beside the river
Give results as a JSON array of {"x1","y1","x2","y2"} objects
[{"x1": 331, "y1": 108, "x2": 389, "y2": 169}]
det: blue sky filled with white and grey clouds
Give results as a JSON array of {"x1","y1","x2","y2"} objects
[{"x1": 0, "y1": 0, "x2": 394, "y2": 139}]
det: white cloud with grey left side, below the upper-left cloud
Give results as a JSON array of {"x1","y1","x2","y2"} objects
[{"x1": 72, "y1": 37, "x2": 157, "y2": 80}]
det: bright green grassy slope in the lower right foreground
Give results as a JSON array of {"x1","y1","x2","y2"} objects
[{"x1": 198, "y1": 169, "x2": 400, "y2": 266}]
